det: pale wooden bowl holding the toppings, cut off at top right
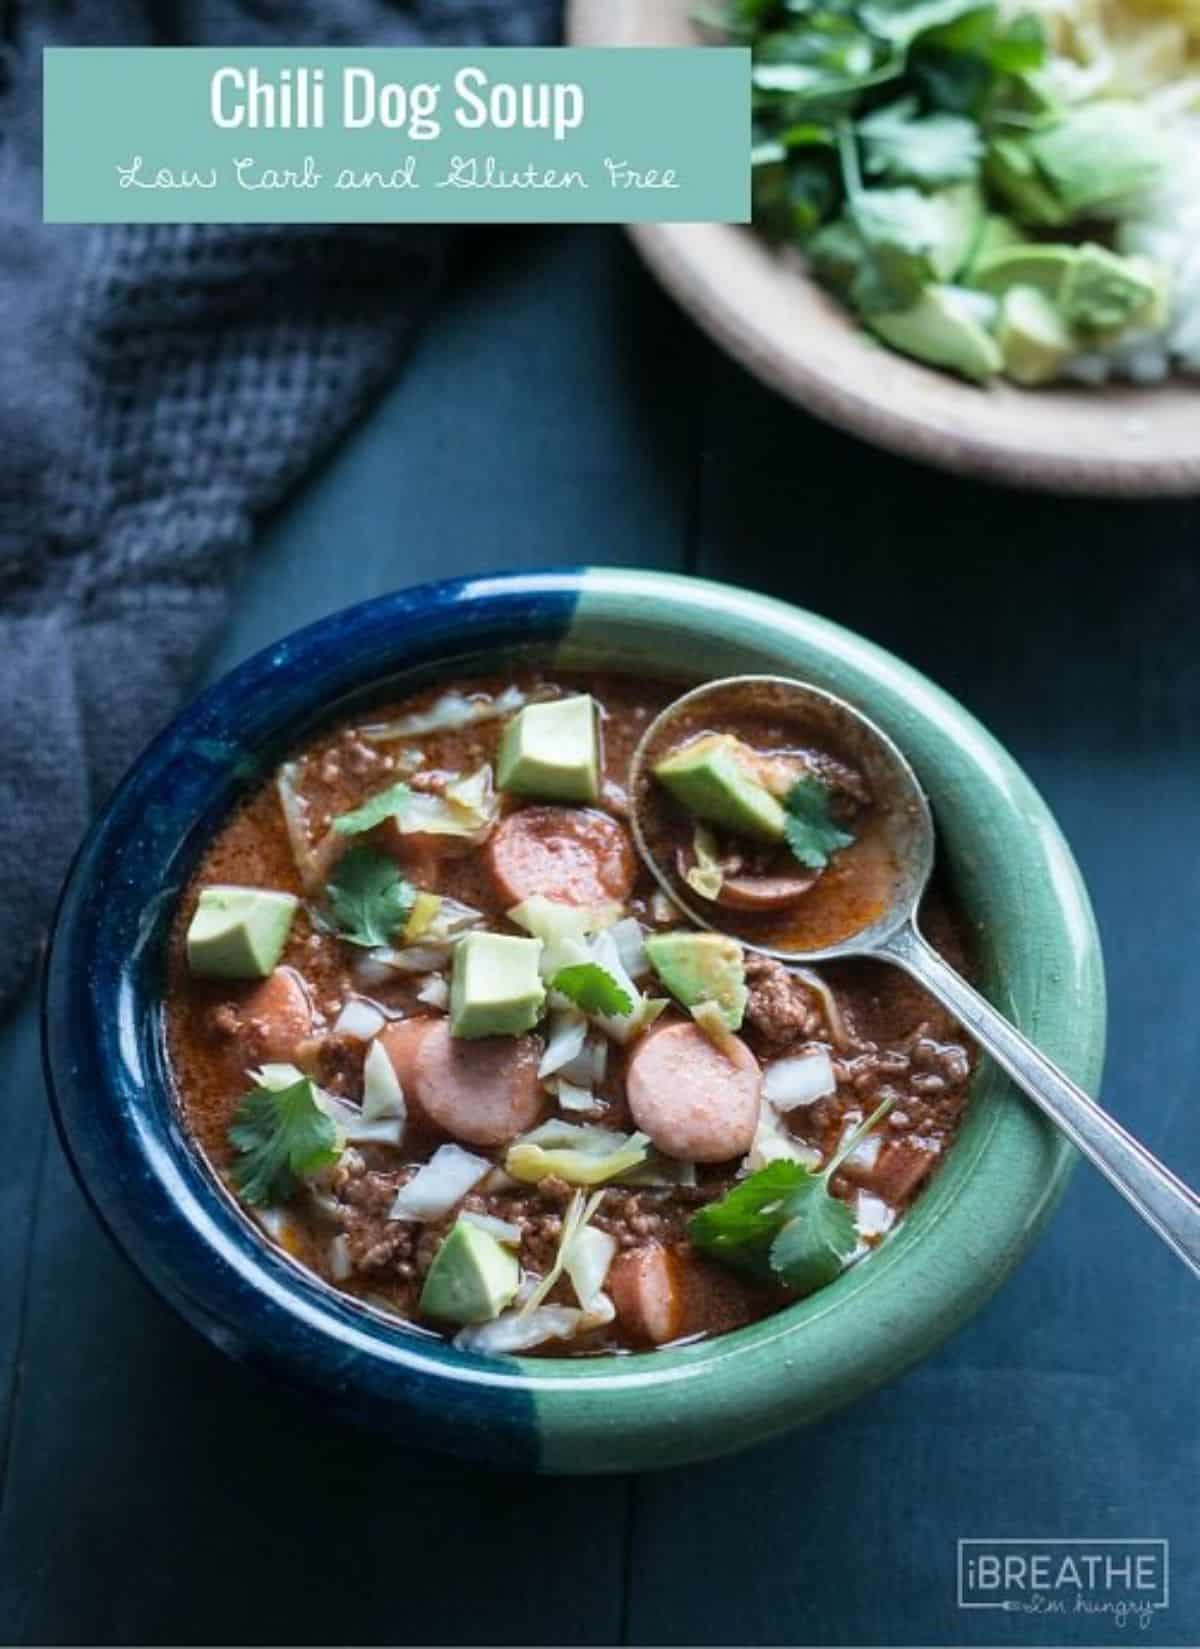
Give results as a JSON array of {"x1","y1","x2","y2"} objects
[{"x1": 567, "y1": 0, "x2": 1200, "y2": 498}]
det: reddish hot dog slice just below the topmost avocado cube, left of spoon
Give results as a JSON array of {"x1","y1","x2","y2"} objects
[{"x1": 485, "y1": 808, "x2": 635, "y2": 907}]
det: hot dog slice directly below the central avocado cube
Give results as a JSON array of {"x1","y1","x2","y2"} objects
[{"x1": 407, "y1": 1019, "x2": 544, "y2": 1146}]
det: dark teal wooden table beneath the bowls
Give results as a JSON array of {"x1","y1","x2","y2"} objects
[{"x1": 0, "y1": 229, "x2": 1200, "y2": 1646}]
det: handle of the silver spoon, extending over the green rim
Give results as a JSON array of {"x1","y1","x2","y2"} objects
[{"x1": 875, "y1": 925, "x2": 1200, "y2": 1276}]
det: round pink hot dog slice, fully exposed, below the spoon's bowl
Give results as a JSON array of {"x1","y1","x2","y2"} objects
[{"x1": 625, "y1": 1021, "x2": 763, "y2": 1163}]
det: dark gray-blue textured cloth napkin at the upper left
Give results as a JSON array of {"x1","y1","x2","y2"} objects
[{"x1": 0, "y1": 0, "x2": 557, "y2": 1011}]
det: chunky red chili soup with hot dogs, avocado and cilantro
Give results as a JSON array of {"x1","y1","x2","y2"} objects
[{"x1": 166, "y1": 669, "x2": 973, "y2": 1355}]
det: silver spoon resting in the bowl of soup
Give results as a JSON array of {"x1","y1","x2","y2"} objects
[{"x1": 630, "y1": 676, "x2": 1200, "y2": 1276}]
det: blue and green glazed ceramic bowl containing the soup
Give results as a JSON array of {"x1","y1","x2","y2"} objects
[{"x1": 45, "y1": 569, "x2": 1104, "y2": 1471}]
